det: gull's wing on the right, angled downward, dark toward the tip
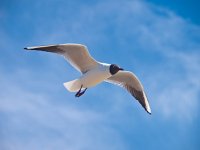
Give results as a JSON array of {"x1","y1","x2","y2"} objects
[{"x1": 106, "y1": 71, "x2": 151, "y2": 114}]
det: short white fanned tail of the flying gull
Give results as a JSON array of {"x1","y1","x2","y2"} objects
[{"x1": 63, "y1": 79, "x2": 81, "y2": 92}]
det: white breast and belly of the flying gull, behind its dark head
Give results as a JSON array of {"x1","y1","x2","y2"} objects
[{"x1": 80, "y1": 64, "x2": 111, "y2": 88}]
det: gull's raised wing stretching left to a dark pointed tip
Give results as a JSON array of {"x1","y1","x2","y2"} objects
[{"x1": 24, "y1": 44, "x2": 97, "y2": 73}]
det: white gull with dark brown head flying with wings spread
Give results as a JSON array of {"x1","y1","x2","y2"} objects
[{"x1": 24, "y1": 43, "x2": 151, "y2": 114}]
